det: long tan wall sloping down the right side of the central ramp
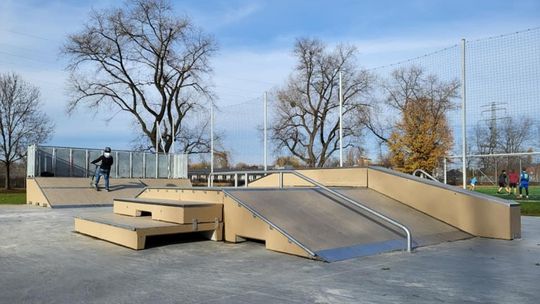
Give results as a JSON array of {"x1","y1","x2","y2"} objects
[{"x1": 368, "y1": 168, "x2": 521, "y2": 240}]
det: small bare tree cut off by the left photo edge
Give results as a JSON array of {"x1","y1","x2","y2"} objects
[{"x1": 0, "y1": 74, "x2": 54, "y2": 189}]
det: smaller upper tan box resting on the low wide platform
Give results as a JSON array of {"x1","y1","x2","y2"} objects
[{"x1": 113, "y1": 198, "x2": 223, "y2": 224}]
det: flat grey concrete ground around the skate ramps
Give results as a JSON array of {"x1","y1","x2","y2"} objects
[{"x1": 0, "y1": 206, "x2": 540, "y2": 303}]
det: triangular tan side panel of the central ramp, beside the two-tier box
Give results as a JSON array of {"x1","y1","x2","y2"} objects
[{"x1": 223, "y1": 196, "x2": 314, "y2": 258}]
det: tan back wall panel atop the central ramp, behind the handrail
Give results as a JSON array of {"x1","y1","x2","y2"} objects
[{"x1": 248, "y1": 168, "x2": 368, "y2": 188}]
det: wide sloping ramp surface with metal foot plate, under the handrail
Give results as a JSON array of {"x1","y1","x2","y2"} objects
[{"x1": 225, "y1": 188, "x2": 470, "y2": 262}]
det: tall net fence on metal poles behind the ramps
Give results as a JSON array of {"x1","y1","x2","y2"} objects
[{"x1": 199, "y1": 28, "x2": 540, "y2": 184}]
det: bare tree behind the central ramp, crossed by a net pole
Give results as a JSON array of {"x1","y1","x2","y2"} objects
[{"x1": 271, "y1": 39, "x2": 371, "y2": 167}]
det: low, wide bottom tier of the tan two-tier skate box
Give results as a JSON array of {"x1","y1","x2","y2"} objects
[{"x1": 75, "y1": 212, "x2": 223, "y2": 250}]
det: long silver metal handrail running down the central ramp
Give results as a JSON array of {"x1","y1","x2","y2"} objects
[{"x1": 208, "y1": 170, "x2": 412, "y2": 252}]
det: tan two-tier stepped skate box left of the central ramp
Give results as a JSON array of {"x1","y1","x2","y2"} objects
[{"x1": 75, "y1": 189, "x2": 223, "y2": 250}]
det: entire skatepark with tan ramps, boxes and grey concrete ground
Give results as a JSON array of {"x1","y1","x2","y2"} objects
[{"x1": 0, "y1": 145, "x2": 540, "y2": 303}]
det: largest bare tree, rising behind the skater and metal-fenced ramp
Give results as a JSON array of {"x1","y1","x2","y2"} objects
[{"x1": 62, "y1": 0, "x2": 217, "y2": 153}]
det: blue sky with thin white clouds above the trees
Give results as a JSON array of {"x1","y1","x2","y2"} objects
[{"x1": 0, "y1": 0, "x2": 540, "y2": 164}]
